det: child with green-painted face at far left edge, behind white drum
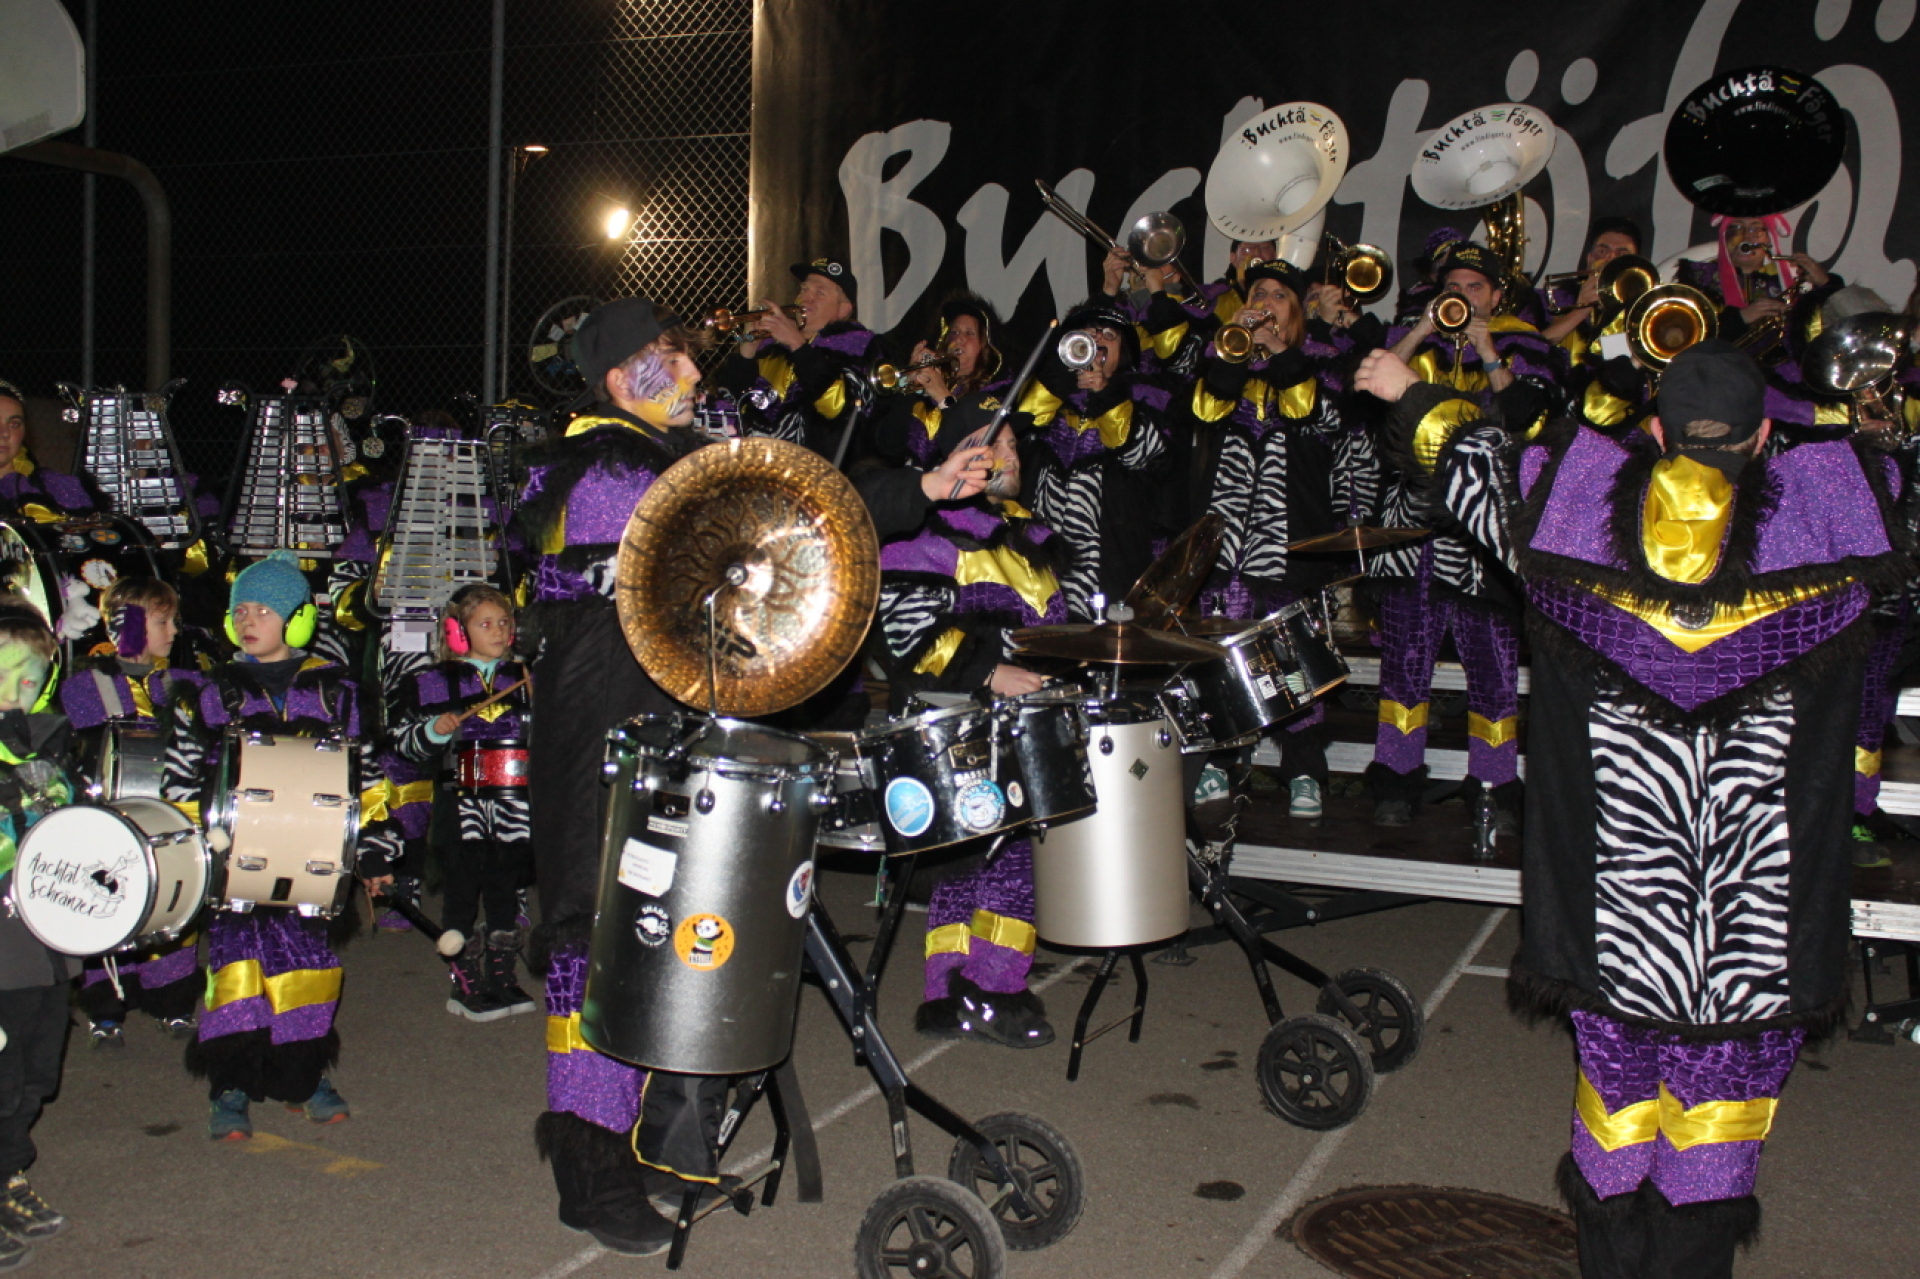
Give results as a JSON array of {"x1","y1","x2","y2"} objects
[{"x1": 0, "y1": 595, "x2": 81, "y2": 1269}]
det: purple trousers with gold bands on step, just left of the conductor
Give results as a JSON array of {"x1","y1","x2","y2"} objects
[{"x1": 1373, "y1": 578, "x2": 1521, "y2": 785}]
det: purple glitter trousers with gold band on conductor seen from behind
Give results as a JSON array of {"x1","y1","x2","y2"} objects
[{"x1": 1572, "y1": 1012, "x2": 1807, "y2": 1206}]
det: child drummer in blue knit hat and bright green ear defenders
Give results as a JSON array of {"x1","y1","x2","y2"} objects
[{"x1": 161, "y1": 551, "x2": 397, "y2": 1141}]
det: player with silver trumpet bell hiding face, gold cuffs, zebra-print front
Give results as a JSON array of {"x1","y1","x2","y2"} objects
[{"x1": 1016, "y1": 298, "x2": 1169, "y2": 622}]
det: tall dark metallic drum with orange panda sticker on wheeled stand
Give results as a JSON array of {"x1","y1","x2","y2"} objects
[{"x1": 580, "y1": 714, "x2": 833, "y2": 1075}]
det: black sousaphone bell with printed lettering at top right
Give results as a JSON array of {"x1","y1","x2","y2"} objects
[{"x1": 1661, "y1": 67, "x2": 1847, "y2": 217}]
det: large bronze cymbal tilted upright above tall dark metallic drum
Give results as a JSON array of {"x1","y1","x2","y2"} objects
[{"x1": 614, "y1": 438, "x2": 879, "y2": 716}]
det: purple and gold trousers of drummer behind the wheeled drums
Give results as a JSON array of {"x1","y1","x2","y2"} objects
[{"x1": 925, "y1": 839, "x2": 1033, "y2": 1001}]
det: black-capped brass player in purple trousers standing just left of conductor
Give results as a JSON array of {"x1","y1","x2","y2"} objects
[{"x1": 1367, "y1": 240, "x2": 1561, "y2": 833}]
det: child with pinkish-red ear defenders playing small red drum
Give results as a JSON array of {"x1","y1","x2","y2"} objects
[{"x1": 394, "y1": 584, "x2": 540, "y2": 1022}]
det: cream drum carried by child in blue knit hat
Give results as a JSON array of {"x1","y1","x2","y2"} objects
[{"x1": 207, "y1": 730, "x2": 361, "y2": 918}]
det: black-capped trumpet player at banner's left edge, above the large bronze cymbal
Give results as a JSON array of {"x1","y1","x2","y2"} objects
[{"x1": 720, "y1": 257, "x2": 879, "y2": 457}]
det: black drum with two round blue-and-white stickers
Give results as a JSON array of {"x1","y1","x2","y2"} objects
[{"x1": 860, "y1": 703, "x2": 1031, "y2": 855}]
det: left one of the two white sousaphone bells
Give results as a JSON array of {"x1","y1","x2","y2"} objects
[{"x1": 1206, "y1": 102, "x2": 1348, "y2": 242}]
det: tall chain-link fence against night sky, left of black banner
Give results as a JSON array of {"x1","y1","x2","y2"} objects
[{"x1": 0, "y1": 0, "x2": 753, "y2": 482}]
